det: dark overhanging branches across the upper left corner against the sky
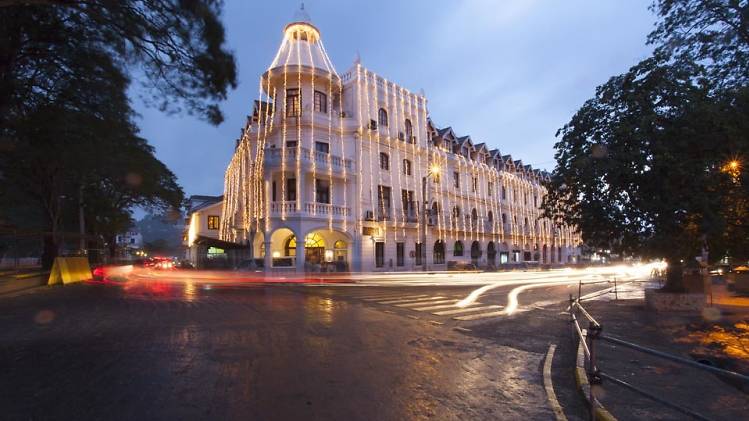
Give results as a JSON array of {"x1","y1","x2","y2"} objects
[{"x1": 0, "y1": 0, "x2": 236, "y2": 124}]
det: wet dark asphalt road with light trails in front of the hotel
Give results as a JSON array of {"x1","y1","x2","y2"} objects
[{"x1": 0, "y1": 272, "x2": 648, "y2": 420}]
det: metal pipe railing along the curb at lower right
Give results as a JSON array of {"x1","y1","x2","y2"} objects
[{"x1": 569, "y1": 288, "x2": 749, "y2": 420}]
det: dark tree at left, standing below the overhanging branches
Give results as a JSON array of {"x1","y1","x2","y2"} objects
[{"x1": 0, "y1": 27, "x2": 183, "y2": 267}]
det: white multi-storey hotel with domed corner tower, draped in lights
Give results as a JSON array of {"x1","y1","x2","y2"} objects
[{"x1": 184, "y1": 10, "x2": 580, "y2": 272}]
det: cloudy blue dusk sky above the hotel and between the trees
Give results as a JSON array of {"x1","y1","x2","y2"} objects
[{"x1": 135, "y1": 0, "x2": 655, "y2": 195}]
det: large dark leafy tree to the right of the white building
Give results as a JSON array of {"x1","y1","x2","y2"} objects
[{"x1": 543, "y1": 0, "x2": 749, "y2": 290}]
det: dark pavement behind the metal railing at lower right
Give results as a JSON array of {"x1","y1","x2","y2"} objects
[{"x1": 583, "y1": 300, "x2": 749, "y2": 420}]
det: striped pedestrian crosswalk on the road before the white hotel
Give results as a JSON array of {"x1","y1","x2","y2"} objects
[{"x1": 354, "y1": 292, "x2": 505, "y2": 322}]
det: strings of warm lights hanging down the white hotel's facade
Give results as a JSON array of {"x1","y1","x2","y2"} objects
[{"x1": 219, "y1": 13, "x2": 578, "y2": 270}]
